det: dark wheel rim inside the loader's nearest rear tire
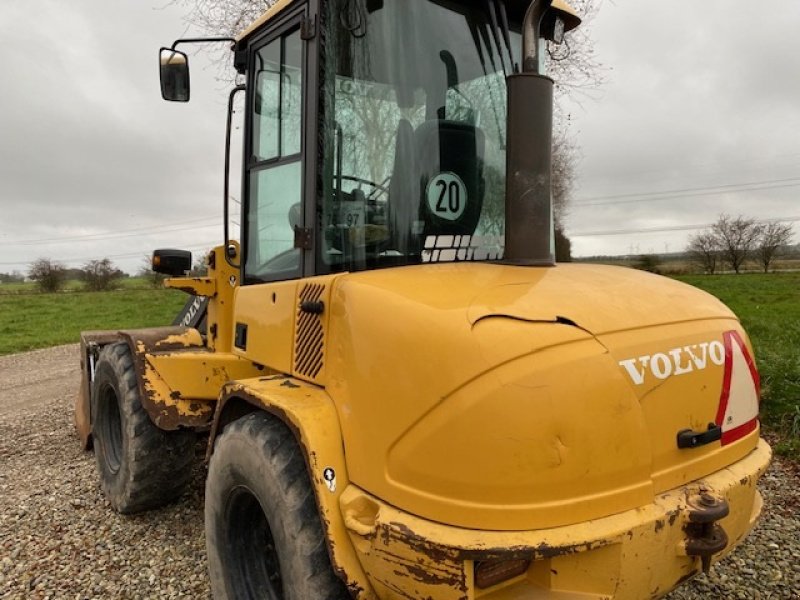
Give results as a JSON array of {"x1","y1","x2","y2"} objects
[{"x1": 223, "y1": 487, "x2": 283, "y2": 600}]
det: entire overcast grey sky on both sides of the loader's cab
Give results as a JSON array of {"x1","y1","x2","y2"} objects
[{"x1": 0, "y1": 0, "x2": 800, "y2": 272}]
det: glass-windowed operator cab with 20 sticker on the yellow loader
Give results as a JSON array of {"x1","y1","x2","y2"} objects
[{"x1": 161, "y1": 0, "x2": 577, "y2": 284}]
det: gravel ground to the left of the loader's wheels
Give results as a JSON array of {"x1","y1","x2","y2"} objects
[{"x1": 0, "y1": 346, "x2": 211, "y2": 600}]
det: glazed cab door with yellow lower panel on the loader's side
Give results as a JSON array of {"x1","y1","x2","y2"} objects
[{"x1": 234, "y1": 2, "x2": 317, "y2": 373}]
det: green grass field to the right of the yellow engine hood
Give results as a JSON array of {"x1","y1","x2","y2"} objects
[{"x1": 677, "y1": 273, "x2": 800, "y2": 458}]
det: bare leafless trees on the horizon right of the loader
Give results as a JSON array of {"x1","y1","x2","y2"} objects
[{"x1": 686, "y1": 214, "x2": 794, "y2": 274}]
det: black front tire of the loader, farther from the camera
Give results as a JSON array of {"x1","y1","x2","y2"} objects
[{"x1": 92, "y1": 343, "x2": 195, "y2": 514}]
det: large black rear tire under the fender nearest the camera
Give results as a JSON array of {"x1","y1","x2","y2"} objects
[{"x1": 205, "y1": 412, "x2": 351, "y2": 600}]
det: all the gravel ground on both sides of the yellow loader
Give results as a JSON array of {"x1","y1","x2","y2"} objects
[{"x1": 0, "y1": 345, "x2": 800, "y2": 600}]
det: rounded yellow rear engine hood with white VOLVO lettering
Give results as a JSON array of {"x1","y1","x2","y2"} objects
[{"x1": 326, "y1": 264, "x2": 758, "y2": 530}]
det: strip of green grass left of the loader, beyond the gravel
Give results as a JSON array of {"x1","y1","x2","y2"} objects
[{"x1": 0, "y1": 278, "x2": 187, "y2": 355}]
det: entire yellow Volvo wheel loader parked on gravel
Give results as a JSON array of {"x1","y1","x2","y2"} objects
[{"x1": 76, "y1": 0, "x2": 770, "y2": 600}]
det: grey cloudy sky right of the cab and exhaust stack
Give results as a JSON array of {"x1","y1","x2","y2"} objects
[{"x1": 568, "y1": 0, "x2": 800, "y2": 255}]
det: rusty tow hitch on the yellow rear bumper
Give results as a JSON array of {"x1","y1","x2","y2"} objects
[{"x1": 683, "y1": 490, "x2": 730, "y2": 573}]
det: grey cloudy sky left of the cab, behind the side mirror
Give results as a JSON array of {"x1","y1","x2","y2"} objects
[{"x1": 0, "y1": 0, "x2": 233, "y2": 271}]
